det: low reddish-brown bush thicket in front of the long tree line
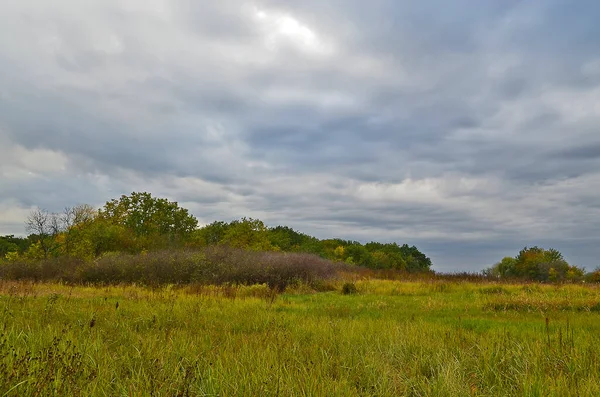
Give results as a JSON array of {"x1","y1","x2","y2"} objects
[{"x1": 0, "y1": 247, "x2": 347, "y2": 290}]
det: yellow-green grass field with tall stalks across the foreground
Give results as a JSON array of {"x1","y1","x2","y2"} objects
[{"x1": 0, "y1": 280, "x2": 600, "y2": 396}]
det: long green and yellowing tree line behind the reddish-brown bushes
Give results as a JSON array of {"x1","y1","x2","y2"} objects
[{"x1": 0, "y1": 192, "x2": 432, "y2": 272}]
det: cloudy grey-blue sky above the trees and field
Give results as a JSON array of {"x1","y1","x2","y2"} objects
[{"x1": 0, "y1": 0, "x2": 600, "y2": 272}]
